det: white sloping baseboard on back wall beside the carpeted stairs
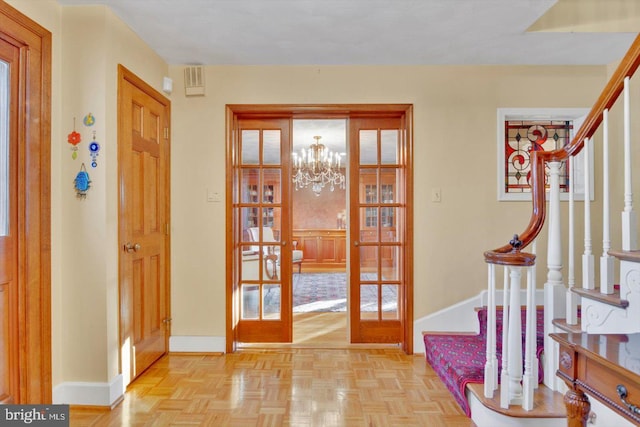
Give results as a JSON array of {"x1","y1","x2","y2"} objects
[{"x1": 413, "y1": 289, "x2": 544, "y2": 354}]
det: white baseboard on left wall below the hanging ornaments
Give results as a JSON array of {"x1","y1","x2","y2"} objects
[{"x1": 53, "y1": 374, "x2": 124, "y2": 407}]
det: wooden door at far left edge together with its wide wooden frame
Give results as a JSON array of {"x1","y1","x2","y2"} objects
[{"x1": 0, "y1": 1, "x2": 52, "y2": 404}]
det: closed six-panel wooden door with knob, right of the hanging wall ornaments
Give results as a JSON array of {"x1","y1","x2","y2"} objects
[{"x1": 118, "y1": 67, "x2": 170, "y2": 384}]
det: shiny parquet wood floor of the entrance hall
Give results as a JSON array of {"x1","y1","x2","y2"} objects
[{"x1": 70, "y1": 348, "x2": 474, "y2": 427}]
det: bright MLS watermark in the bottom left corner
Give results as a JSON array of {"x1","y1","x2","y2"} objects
[{"x1": 0, "y1": 405, "x2": 69, "y2": 427}]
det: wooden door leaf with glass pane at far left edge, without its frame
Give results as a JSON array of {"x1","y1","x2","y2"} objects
[{"x1": 0, "y1": 33, "x2": 20, "y2": 404}]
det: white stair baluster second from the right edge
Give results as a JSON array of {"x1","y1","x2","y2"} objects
[{"x1": 600, "y1": 109, "x2": 614, "y2": 294}]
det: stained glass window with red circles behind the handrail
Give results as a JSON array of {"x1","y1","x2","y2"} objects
[{"x1": 504, "y1": 120, "x2": 573, "y2": 194}]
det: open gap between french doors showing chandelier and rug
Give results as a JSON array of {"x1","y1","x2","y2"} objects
[{"x1": 291, "y1": 118, "x2": 349, "y2": 348}]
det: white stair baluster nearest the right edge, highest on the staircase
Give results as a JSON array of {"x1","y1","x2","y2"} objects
[{"x1": 622, "y1": 77, "x2": 638, "y2": 251}]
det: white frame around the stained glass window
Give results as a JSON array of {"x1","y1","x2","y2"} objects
[{"x1": 496, "y1": 108, "x2": 594, "y2": 202}]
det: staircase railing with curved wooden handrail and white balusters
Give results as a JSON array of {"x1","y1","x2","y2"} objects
[{"x1": 482, "y1": 31, "x2": 640, "y2": 425}]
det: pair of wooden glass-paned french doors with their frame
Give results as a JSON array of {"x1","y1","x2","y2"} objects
[{"x1": 227, "y1": 104, "x2": 413, "y2": 354}]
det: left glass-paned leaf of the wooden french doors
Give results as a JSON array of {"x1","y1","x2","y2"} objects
[{"x1": 232, "y1": 118, "x2": 293, "y2": 343}]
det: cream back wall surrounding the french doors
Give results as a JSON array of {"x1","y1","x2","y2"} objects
[{"x1": 170, "y1": 66, "x2": 607, "y2": 344}]
